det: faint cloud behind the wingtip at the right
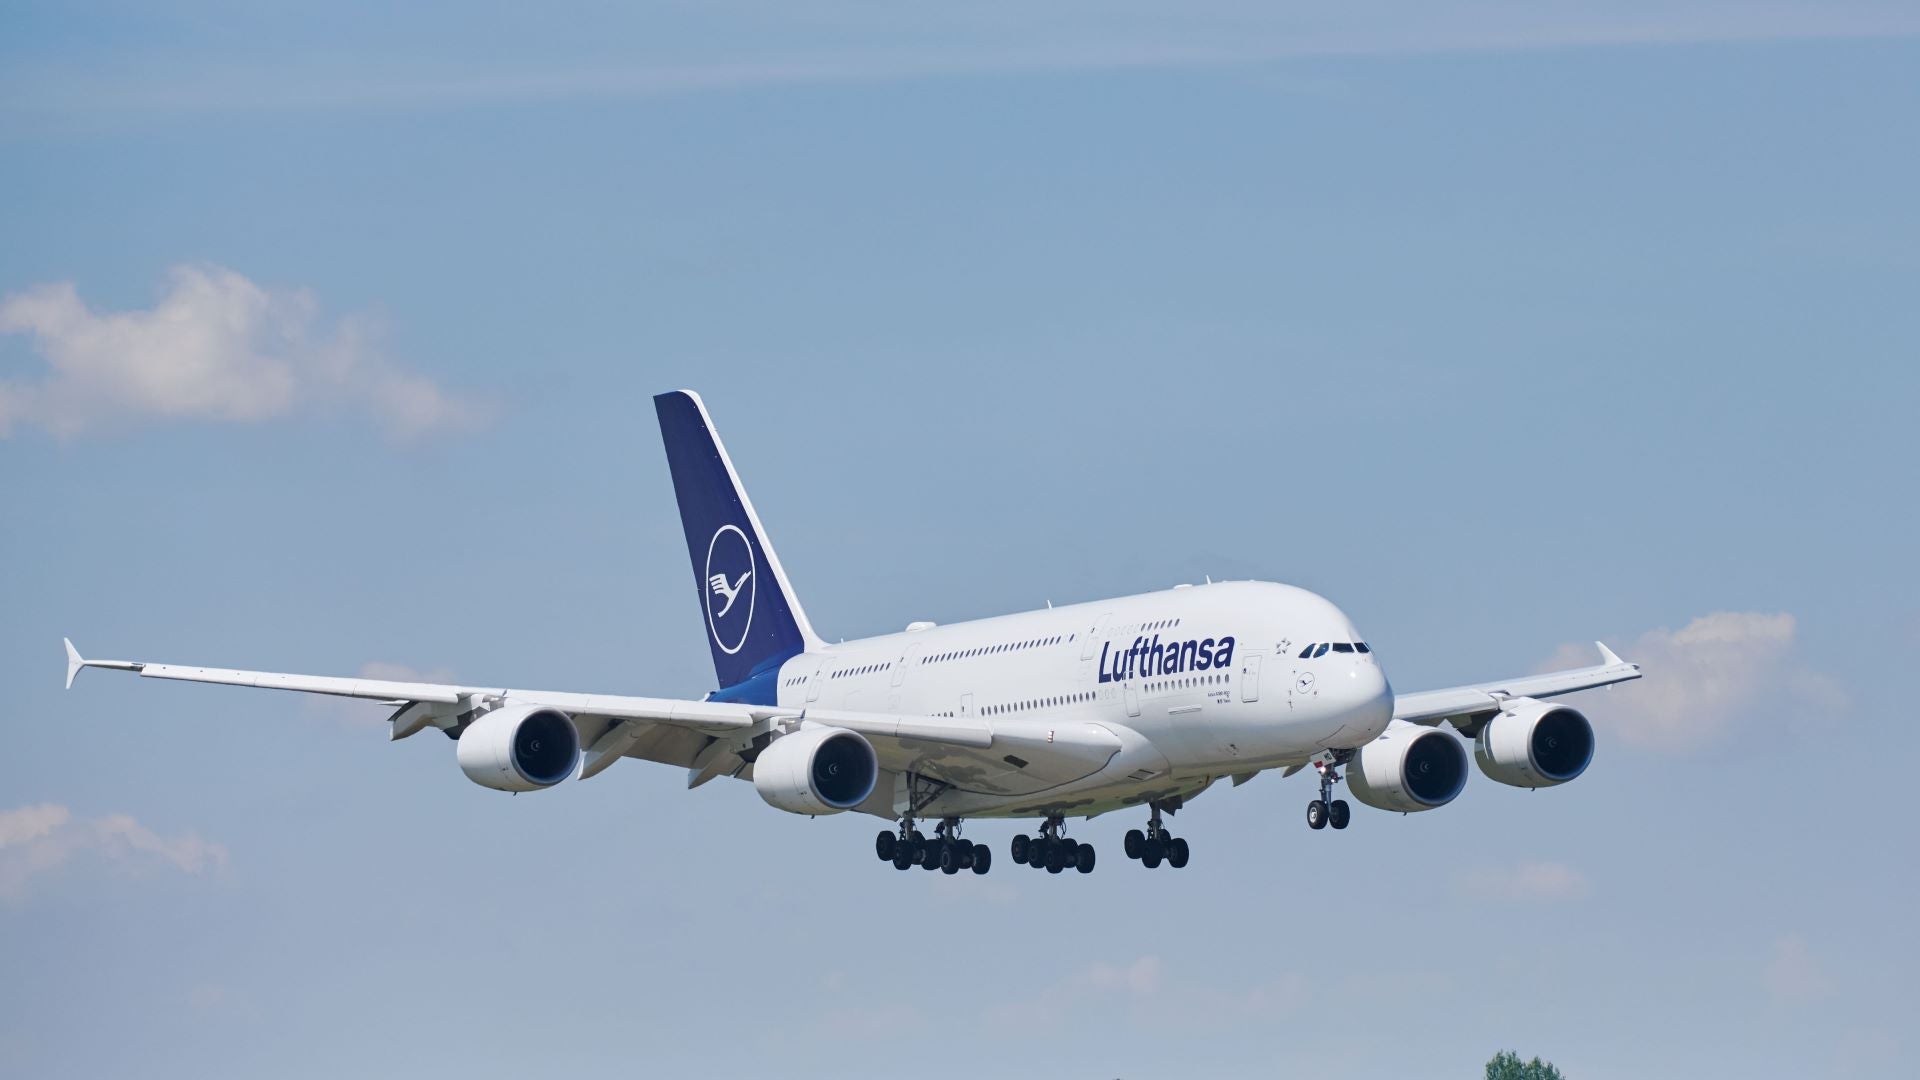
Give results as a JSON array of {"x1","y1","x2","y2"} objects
[{"x1": 1542, "y1": 611, "x2": 1847, "y2": 751}]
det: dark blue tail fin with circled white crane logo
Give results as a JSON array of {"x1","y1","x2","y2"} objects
[{"x1": 653, "y1": 390, "x2": 820, "y2": 687}]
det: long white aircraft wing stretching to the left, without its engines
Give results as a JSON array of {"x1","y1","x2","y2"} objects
[{"x1": 65, "y1": 640, "x2": 1121, "y2": 794}]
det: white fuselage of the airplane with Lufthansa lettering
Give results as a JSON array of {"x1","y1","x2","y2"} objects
[{"x1": 780, "y1": 582, "x2": 1392, "y2": 817}]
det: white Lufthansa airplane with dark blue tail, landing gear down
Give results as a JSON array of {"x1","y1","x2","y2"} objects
[{"x1": 65, "y1": 390, "x2": 1640, "y2": 874}]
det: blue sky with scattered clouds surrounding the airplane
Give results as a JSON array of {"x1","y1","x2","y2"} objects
[{"x1": 0, "y1": 2, "x2": 1920, "y2": 1080}]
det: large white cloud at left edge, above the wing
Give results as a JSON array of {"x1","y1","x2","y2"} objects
[{"x1": 0, "y1": 265, "x2": 482, "y2": 438}]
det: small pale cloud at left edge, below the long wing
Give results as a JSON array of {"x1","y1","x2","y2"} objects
[{"x1": 0, "y1": 803, "x2": 227, "y2": 899}]
